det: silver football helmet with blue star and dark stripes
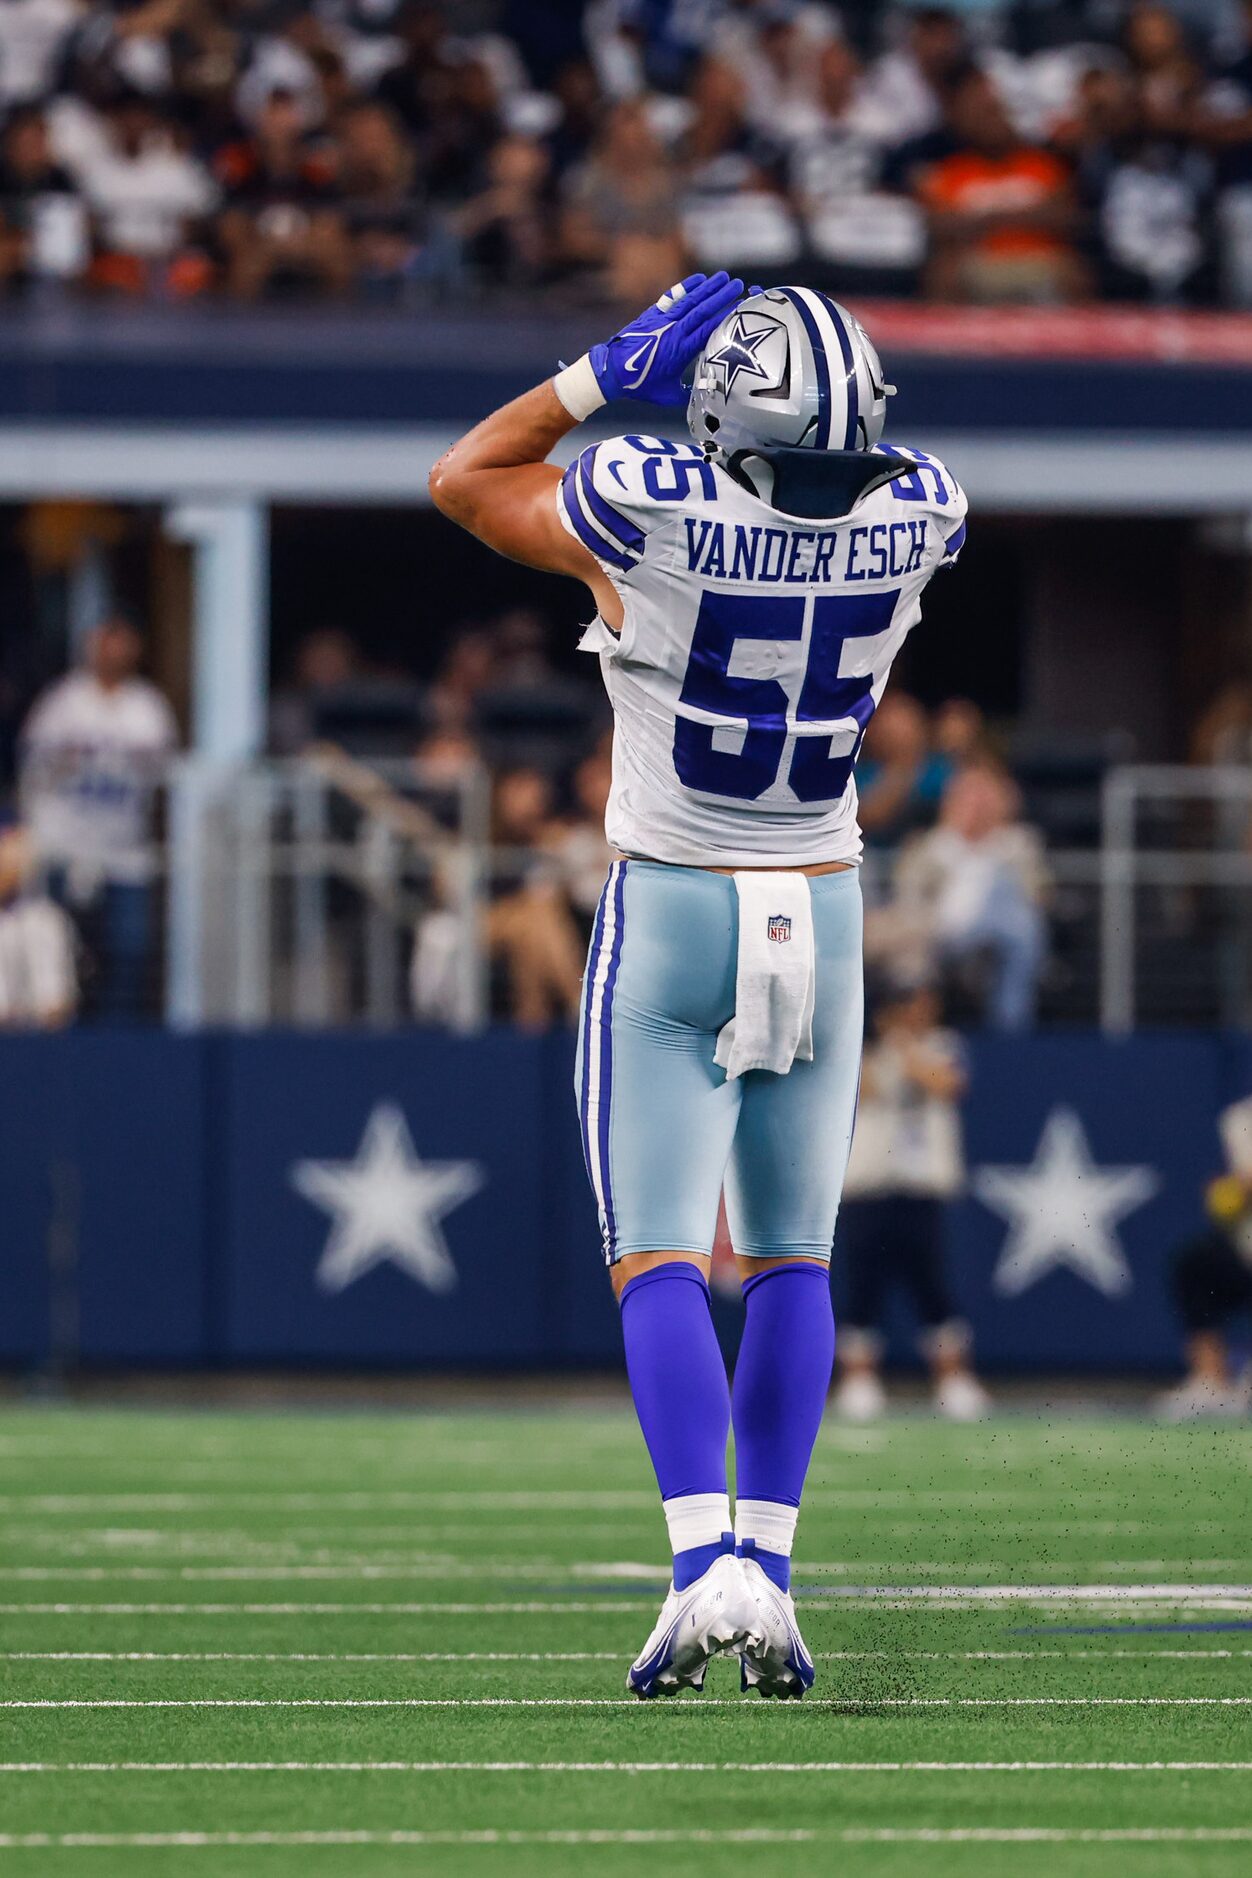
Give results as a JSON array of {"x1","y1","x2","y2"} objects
[{"x1": 687, "y1": 287, "x2": 895, "y2": 456}]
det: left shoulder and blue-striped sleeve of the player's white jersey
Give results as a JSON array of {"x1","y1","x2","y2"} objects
[{"x1": 559, "y1": 436, "x2": 717, "y2": 573}]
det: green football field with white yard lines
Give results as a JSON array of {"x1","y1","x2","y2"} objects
[{"x1": 0, "y1": 1407, "x2": 1252, "y2": 1878}]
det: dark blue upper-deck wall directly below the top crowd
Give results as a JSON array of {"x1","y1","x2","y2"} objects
[{"x1": 0, "y1": 306, "x2": 1252, "y2": 431}]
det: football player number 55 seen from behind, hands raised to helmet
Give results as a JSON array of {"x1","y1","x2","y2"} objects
[{"x1": 430, "y1": 274, "x2": 965, "y2": 1698}]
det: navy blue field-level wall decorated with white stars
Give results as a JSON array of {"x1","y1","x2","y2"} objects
[{"x1": 0, "y1": 1031, "x2": 1252, "y2": 1373}]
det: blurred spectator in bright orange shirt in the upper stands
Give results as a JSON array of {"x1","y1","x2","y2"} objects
[{"x1": 916, "y1": 68, "x2": 1089, "y2": 302}]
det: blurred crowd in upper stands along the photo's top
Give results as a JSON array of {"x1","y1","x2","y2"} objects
[{"x1": 0, "y1": 0, "x2": 1252, "y2": 306}]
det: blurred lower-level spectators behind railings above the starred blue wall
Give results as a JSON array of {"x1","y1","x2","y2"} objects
[{"x1": 0, "y1": 608, "x2": 1049, "y2": 1029}]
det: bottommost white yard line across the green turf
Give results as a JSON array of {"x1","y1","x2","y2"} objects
[{"x1": 0, "y1": 1825, "x2": 1252, "y2": 1852}]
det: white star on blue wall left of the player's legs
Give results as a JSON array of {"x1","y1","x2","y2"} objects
[{"x1": 291, "y1": 1102, "x2": 486, "y2": 1292}]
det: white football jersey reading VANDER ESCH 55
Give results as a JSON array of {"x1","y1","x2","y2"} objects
[{"x1": 557, "y1": 436, "x2": 965, "y2": 868}]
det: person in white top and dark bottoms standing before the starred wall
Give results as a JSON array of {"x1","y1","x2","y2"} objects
[{"x1": 835, "y1": 984, "x2": 991, "y2": 1422}]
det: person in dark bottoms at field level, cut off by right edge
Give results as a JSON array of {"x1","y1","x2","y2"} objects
[{"x1": 1156, "y1": 1099, "x2": 1252, "y2": 1422}]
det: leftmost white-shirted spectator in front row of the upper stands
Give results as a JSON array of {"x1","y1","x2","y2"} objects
[{"x1": 79, "y1": 92, "x2": 218, "y2": 293}]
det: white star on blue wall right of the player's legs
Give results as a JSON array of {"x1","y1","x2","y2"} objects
[{"x1": 972, "y1": 1108, "x2": 1160, "y2": 1298}]
